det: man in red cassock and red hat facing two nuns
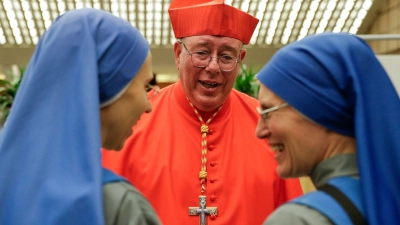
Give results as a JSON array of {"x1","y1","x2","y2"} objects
[{"x1": 103, "y1": 0, "x2": 302, "y2": 225}]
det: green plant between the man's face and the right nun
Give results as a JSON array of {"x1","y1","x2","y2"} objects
[{"x1": 233, "y1": 64, "x2": 260, "y2": 98}]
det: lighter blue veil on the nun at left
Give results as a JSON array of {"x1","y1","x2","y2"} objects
[{"x1": 0, "y1": 9, "x2": 149, "y2": 225}]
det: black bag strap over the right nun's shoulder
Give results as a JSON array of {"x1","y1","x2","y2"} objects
[{"x1": 318, "y1": 184, "x2": 368, "y2": 225}]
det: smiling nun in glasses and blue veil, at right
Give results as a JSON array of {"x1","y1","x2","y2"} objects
[{"x1": 256, "y1": 33, "x2": 400, "y2": 225}]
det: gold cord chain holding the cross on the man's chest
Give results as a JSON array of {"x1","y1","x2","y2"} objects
[{"x1": 188, "y1": 99, "x2": 222, "y2": 194}]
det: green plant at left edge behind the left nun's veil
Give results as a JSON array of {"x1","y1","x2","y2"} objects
[{"x1": 0, "y1": 67, "x2": 25, "y2": 125}]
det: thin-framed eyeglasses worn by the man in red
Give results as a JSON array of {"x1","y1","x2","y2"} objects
[{"x1": 178, "y1": 40, "x2": 240, "y2": 72}]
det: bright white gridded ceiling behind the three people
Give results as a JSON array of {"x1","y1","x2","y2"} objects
[{"x1": 0, "y1": 0, "x2": 382, "y2": 80}]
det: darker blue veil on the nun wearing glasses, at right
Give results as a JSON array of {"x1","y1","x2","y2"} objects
[{"x1": 257, "y1": 33, "x2": 400, "y2": 225}]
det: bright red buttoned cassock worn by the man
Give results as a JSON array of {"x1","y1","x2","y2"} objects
[{"x1": 103, "y1": 81, "x2": 303, "y2": 225}]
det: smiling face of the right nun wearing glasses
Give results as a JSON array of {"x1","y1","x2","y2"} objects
[{"x1": 256, "y1": 84, "x2": 330, "y2": 178}]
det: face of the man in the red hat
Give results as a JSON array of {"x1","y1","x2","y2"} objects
[{"x1": 174, "y1": 35, "x2": 246, "y2": 112}]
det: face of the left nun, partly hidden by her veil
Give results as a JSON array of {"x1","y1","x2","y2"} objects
[{"x1": 100, "y1": 52, "x2": 153, "y2": 150}]
